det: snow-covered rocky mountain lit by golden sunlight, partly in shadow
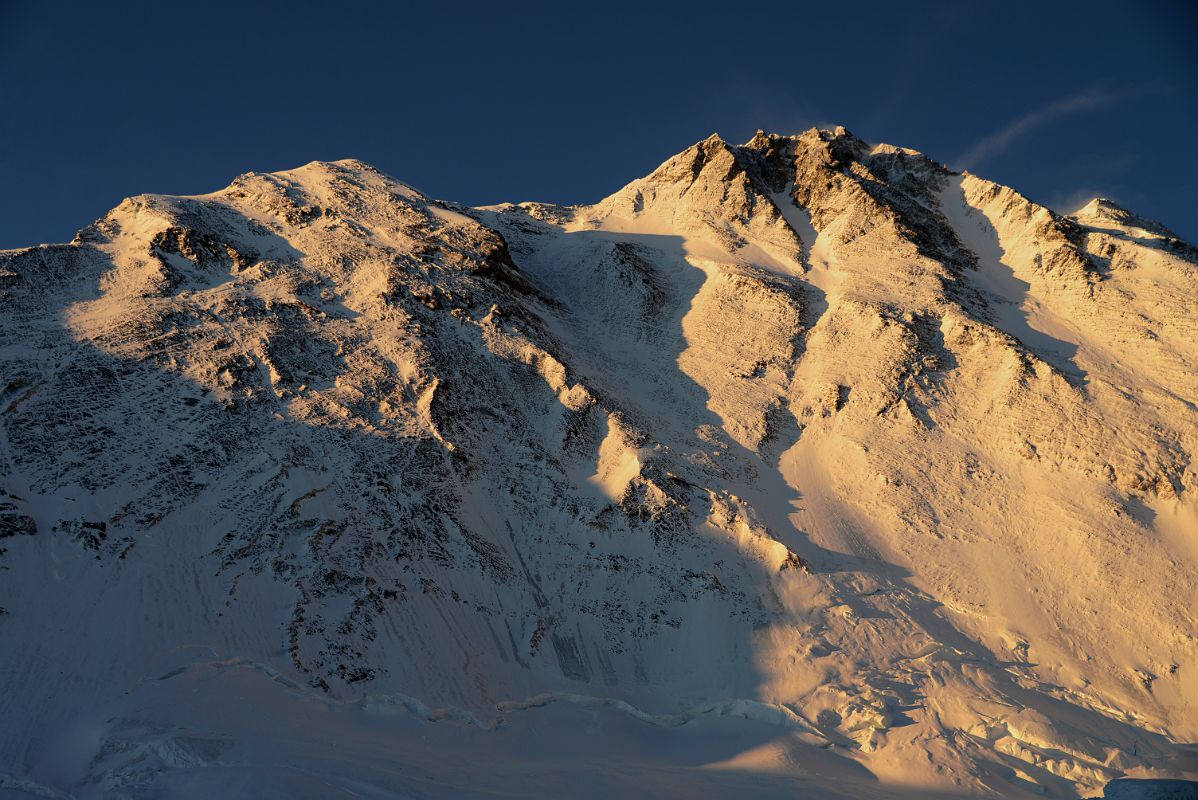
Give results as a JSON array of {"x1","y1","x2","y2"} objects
[{"x1": 0, "y1": 128, "x2": 1198, "y2": 798}]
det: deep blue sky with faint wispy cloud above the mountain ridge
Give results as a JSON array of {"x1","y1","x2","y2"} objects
[{"x1": 0, "y1": 0, "x2": 1198, "y2": 247}]
